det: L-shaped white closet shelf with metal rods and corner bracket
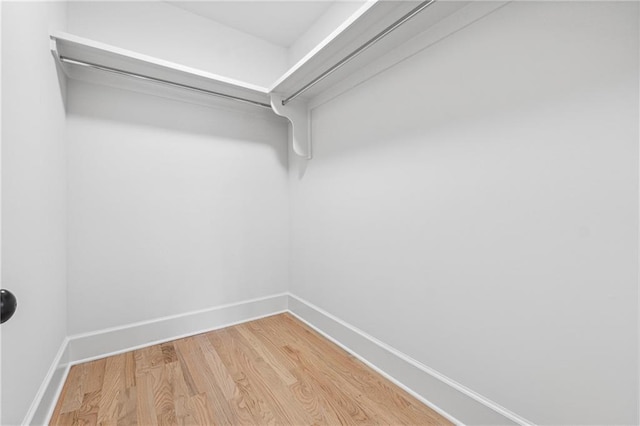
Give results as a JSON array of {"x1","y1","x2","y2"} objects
[{"x1": 51, "y1": 0, "x2": 470, "y2": 159}]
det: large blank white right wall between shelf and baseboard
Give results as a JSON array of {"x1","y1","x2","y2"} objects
[{"x1": 290, "y1": 2, "x2": 639, "y2": 424}]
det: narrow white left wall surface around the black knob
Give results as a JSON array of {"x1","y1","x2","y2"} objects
[{"x1": 0, "y1": 2, "x2": 67, "y2": 425}]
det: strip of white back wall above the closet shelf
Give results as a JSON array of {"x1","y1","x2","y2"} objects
[{"x1": 68, "y1": 1, "x2": 288, "y2": 87}]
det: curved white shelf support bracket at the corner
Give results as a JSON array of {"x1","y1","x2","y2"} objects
[{"x1": 271, "y1": 93, "x2": 311, "y2": 160}]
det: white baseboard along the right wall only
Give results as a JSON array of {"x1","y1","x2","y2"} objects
[{"x1": 289, "y1": 294, "x2": 533, "y2": 426}]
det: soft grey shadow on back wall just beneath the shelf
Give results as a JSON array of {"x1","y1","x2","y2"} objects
[{"x1": 67, "y1": 80, "x2": 288, "y2": 169}]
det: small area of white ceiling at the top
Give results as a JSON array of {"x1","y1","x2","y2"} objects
[{"x1": 169, "y1": 0, "x2": 335, "y2": 47}]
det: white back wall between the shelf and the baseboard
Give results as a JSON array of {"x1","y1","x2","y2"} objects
[{"x1": 67, "y1": 81, "x2": 289, "y2": 334}]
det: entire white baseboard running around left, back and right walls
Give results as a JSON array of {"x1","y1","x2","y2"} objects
[{"x1": 23, "y1": 293, "x2": 533, "y2": 425}]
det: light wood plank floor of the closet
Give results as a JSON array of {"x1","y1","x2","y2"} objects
[{"x1": 51, "y1": 314, "x2": 451, "y2": 426}]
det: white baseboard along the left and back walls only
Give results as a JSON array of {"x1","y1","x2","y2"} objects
[{"x1": 23, "y1": 293, "x2": 288, "y2": 425}]
